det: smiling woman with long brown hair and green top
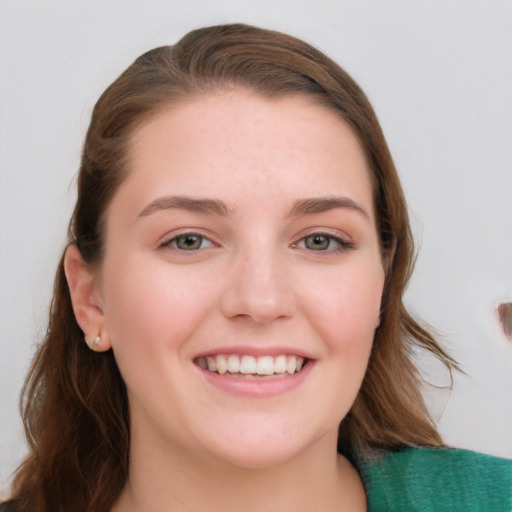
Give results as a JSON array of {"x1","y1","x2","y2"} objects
[{"x1": 4, "y1": 25, "x2": 512, "y2": 512}]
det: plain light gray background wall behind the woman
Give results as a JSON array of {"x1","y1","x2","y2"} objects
[{"x1": 0, "y1": 0, "x2": 512, "y2": 494}]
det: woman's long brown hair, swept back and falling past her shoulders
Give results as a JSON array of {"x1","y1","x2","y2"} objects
[{"x1": 12, "y1": 24, "x2": 455, "y2": 512}]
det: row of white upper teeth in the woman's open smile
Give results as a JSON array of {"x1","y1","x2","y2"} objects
[{"x1": 196, "y1": 354, "x2": 304, "y2": 375}]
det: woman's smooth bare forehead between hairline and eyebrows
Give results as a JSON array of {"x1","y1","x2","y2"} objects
[{"x1": 115, "y1": 90, "x2": 372, "y2": 219}]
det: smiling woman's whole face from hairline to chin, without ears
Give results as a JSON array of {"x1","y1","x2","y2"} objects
[{"x1": 95, "y1": 91, "x2": 384, "y2": 467}]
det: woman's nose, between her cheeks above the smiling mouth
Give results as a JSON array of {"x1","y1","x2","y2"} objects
[{"x1": 221, "y1": 249, "x2": 297, "y2": 324}]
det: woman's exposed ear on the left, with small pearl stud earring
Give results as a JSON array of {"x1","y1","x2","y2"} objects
[{"x1": 64, "y1": 244, "x2": 111, "y2": 352}]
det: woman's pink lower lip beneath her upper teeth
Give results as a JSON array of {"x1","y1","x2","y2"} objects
[{"x1": 197, "y1": 360, "x2": 314, "y2": 398}]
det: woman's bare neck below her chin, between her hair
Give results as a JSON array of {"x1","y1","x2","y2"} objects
[{"x1": 112, "y1": 428, "x2": 366, "y2": 512}]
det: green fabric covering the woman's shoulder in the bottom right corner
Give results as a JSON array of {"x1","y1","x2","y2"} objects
[{"x1": 360, "y1": 448, "x2": 512, "y2": 512}]
